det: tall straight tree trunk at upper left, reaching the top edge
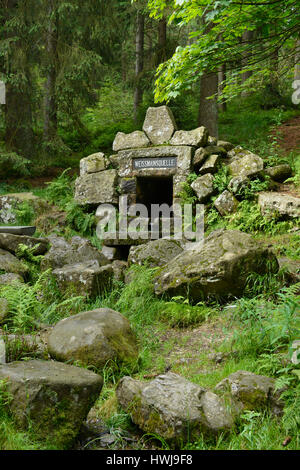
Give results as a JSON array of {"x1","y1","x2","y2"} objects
[{"x1": 44, "y1": 0, "x2": 58, "y2": 141}]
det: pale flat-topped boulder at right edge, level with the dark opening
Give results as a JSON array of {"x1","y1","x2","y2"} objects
[{"x1": 258, "y1": 192, "x2": 300, "y2": 219}]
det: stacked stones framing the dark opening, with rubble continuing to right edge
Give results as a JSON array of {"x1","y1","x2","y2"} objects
[{"x1": 75, "y1": 106, "x2": 300, "y2": 237}]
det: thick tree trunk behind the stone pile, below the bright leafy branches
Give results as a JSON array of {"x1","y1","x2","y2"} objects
[{"x1": 198, "y1": 73, "x2": 219, "y2": 138}]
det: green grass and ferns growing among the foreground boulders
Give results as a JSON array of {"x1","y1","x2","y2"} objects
[{"x1": 0, "y1": 258, "x2": 300, "y2": 449}]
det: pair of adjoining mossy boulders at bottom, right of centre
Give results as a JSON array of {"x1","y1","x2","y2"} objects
[{"x1": 117, "y1": 371, "x2": 283, "y2": 443}]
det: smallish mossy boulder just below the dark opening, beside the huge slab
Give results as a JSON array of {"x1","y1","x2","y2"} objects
[{"x1": 128, "y1": 238, "x2": 183, "y2": 268}]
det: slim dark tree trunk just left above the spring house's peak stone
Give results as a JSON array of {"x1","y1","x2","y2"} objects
[{"x1": 134, "y1": 11, "x2": 145, "y2": 122}]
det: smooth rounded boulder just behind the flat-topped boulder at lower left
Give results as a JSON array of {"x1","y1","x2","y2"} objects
[{"x1": 48, "y1": 308, "x2": 138, "y2": 369}]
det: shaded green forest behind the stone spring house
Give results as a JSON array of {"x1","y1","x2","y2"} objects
[{"x1": 0, "y1": 0, "x2": 300, "y2": 178}]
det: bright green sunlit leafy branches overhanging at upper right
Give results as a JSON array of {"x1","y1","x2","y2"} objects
[{"x1": 148, "y1": 0, "x2": 300, "y2": 102}]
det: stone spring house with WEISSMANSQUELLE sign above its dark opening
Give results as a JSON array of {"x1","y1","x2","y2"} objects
[{"x1": 75, "y1": 106, "x2": 216, "y2": 245}]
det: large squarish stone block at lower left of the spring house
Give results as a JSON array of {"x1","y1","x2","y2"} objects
[{"x1": 75, "y1": 170, "x2": 118, "y2": 205}]
